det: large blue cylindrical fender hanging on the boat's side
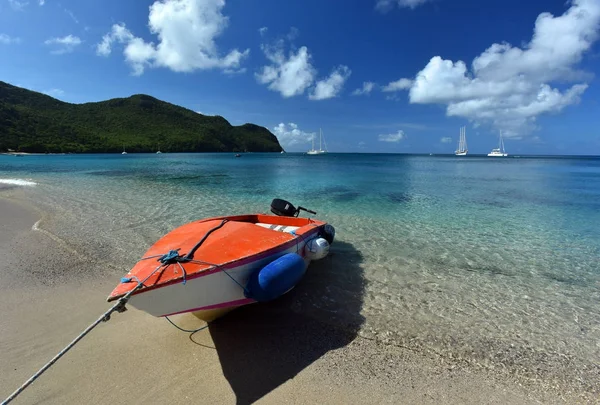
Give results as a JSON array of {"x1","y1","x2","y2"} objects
[{"x1": 244, "y1": 253, "x2": 306, "y2": 302}]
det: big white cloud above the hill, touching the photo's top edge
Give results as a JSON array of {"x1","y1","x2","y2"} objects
[{"x1": 96, "y1": 0, "x2": 250, "y2": 75}]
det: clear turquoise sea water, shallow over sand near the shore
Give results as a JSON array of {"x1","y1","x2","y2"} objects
[{"x1": 0, "y1": 153, "x2": 600, "y2": 392}]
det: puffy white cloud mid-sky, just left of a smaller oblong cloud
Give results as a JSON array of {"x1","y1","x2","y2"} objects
[{"x1": 256, "y1": 41, "x2": 316, "y2": 98}]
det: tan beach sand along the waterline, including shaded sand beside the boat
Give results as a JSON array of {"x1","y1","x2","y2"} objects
[{"x1": 0, "y1": 195, "x2": 594, "y2": 404}]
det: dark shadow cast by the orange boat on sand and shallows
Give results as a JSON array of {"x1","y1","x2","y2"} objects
[{"x1": 197, "y1": 241, "x2": 365, "y2": 404}]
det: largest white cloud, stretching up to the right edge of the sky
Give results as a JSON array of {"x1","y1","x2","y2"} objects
[{"x1": 390, "y1": 0, "x2": 600, "y2": 137}]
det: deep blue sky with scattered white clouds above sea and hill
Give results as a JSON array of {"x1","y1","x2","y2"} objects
[{"x1": 0, "y1": 0, "x2": 600, "y2": 155}]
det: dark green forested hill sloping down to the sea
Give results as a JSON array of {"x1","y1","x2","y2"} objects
[{"x1": 0, "y1": 81, "x2": 282, "y2": 153}]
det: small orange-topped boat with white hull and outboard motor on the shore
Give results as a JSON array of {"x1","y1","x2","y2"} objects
[{"x1": 108, "y1": 199, "x2": 335, "y2": 321}]
